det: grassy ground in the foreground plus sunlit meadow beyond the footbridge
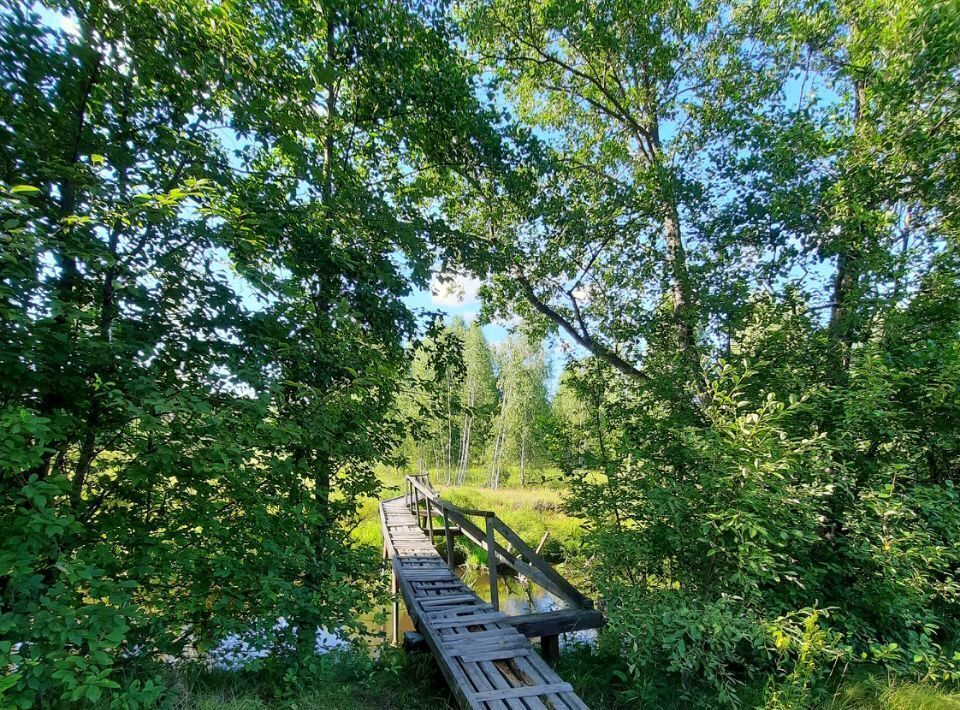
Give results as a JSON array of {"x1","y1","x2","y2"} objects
[{"x1": 174, "y1": 468, "x2": 960, "y2": 710}]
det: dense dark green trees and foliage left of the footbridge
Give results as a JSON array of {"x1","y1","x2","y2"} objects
[{"x1": 0, "y1": 0, "x2": 495, "y2": 707}]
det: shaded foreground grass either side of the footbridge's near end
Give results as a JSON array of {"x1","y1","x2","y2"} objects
[{"x1": 127, "y1": 648, "x2": 960, "y2": 710}]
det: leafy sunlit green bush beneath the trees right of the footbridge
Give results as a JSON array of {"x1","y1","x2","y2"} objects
[{"x1": 570, "y1": 344, "x2": 960, "y2": 705}]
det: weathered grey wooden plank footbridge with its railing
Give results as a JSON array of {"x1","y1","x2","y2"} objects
[{"x1": 380, "y1": 476, "x2": 603, "y2": 710}]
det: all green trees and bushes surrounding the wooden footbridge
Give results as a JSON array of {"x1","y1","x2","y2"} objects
[{"x1": 0, "y1": 0, "x2": 960, "y2": 707}]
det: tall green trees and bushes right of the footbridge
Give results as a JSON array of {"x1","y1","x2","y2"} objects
[{"x1": 448, "y1": 0, "x2": 960, "y2": 704}]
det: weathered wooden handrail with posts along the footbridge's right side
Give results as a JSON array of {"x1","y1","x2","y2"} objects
[{"x1": 404, "y1": 474, "x2": 593, "y2": 609}]
